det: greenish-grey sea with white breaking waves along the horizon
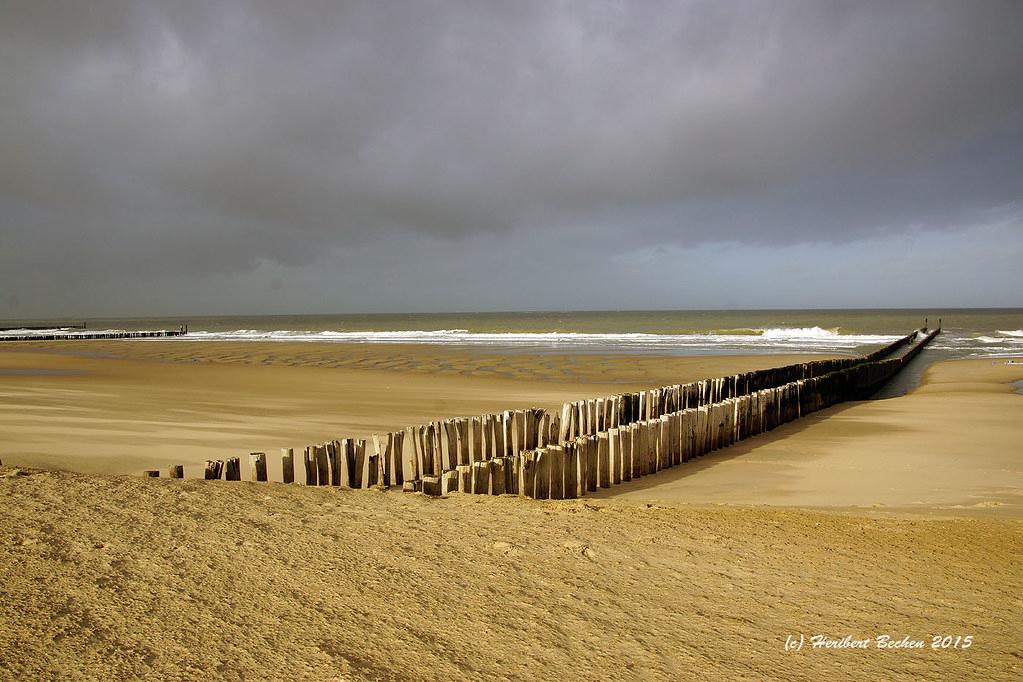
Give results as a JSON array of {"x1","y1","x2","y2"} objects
[{"x1": 0, "y1": 308, "x2": 1023, "y2": 361}]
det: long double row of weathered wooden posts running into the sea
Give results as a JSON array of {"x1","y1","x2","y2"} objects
[{"x1": 146, "y1": 326, "x2": 941, "y2": 499}]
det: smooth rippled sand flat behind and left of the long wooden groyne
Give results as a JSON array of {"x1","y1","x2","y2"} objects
[{"x1": 0, "y1": 342, "x2": 820, "y2": 475}]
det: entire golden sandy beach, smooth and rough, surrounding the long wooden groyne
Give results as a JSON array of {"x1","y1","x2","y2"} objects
[{"x1": 0, "y1": 342, "x2": 1023, "y2": 680}]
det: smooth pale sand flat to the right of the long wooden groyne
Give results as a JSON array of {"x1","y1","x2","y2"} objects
[{"x1": 599, "y1": 359, "x2": 1023, "y2": 518}]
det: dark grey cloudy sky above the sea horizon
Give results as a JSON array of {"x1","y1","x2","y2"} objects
[{"x1": 0, "y1": 0, "x2": 1023, "y2": 319}]
